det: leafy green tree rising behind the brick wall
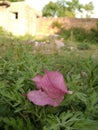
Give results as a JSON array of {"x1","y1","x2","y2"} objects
[{"x1": 42, "y1": 0, "x2": 94, "y2": 17}]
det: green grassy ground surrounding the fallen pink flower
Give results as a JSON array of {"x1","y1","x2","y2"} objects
[{"x1": 0, "y1": 29, "x2": 98, "y2": 130}]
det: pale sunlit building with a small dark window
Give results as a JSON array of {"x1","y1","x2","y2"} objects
[{"x1": 0, "y1": 1, "x2": 42, "y2": 36}]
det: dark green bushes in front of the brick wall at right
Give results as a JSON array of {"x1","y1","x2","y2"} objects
[{"x1": 58, "y1": 27, "x2": 98, "y2": 44}]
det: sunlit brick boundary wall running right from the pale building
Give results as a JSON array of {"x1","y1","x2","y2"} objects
[{"x1": 35, "y1": 17, "x2": 98, "y2": 35}]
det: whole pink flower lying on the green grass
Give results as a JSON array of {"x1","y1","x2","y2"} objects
[{"x1": 27, "y1": 70, "x2": 72, "y2": 107}]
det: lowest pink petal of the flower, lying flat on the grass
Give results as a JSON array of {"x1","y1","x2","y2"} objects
[{"x1": 27, "y1": 90, "x2": 64, "y2": 107}]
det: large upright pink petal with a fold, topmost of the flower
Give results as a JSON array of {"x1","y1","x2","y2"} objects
[{"x1": 41, "y1": 71, "x2": 67, "y2": 98}]
